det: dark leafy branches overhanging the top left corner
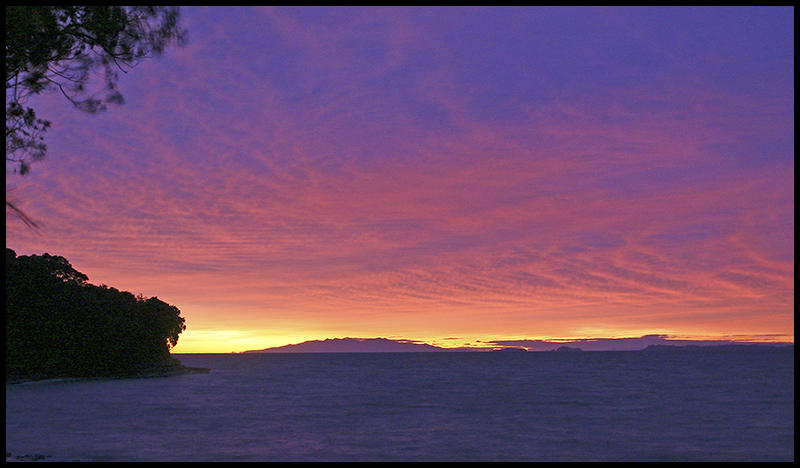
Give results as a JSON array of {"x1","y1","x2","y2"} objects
[{"x1": 6, "y1": 5, "x2": 186, "y2": 226}]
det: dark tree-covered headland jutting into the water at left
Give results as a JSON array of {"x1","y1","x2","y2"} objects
[{"x1": 6, "y1": 248, "x2": 186, "y2": 380}]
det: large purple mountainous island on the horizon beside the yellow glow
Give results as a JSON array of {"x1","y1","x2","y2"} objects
[{"x1": 245, "y1": 338, "x2": 452, "y2": 353}]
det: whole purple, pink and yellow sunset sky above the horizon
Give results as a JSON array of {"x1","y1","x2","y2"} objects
[{"x1": 6, "y1": 7, "x2": 794, "y2": 353}]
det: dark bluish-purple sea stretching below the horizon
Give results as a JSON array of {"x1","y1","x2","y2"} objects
[{"x1": 6, "y1": 347, "x2": 794, "y2": 462}]
